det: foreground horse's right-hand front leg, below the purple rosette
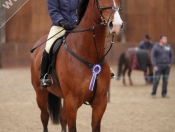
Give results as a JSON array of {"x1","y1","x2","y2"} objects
[{"x1": 91, "y1": 94, "x2": 107, "y2": 132}]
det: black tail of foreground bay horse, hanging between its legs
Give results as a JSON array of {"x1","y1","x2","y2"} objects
[{"x1": 48, "y1": 92, "x2": 61, "y2": 124}]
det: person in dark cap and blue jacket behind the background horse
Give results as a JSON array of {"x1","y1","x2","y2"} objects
[{"x1": 139, "y1": 34, "x2": 153, "y2": 50}]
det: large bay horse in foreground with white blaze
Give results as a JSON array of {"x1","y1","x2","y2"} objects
[{"x1": 31, "y1": 0, "x2": 123, "y2": 132}]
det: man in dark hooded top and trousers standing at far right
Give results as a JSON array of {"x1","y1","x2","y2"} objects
[{"x1": 151, "y1": 35, "x2": 174, "y2": 97}]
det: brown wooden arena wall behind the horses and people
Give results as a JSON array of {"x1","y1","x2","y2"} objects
[{"x1": 2, "y1": 0, "x2": 175, "y2": 67}]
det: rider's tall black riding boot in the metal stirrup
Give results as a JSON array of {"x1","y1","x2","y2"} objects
[{"x1": 40, "y1": 50, "x2": 53, "y2": 89}]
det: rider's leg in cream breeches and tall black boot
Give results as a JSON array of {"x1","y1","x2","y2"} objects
[{"x1": 40, "y1": 26, "x2": 65, "y2": 89}]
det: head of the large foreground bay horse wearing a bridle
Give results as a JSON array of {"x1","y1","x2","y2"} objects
[{"x1": 95, "y1": 0, "x2": 123, "y2": 34}]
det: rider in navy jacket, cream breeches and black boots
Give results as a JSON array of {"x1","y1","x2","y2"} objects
[{"x1": 40, "y1": 0, "x2": 79, "y2": 88}]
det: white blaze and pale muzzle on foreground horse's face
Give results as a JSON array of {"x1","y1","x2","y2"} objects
[{"x1": 110, "y1": 11, "x2": 123, "y2": 34}]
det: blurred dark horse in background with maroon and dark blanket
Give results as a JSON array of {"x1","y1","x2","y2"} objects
[{"x1": 117, "y1": 48, "x2": 153, "y2": 85}]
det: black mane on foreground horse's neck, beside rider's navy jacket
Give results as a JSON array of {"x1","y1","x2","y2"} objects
[{"x1": 77, "y1": 0, "x2": 89, "y2": 23}]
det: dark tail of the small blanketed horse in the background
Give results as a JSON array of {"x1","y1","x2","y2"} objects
[{"x1": 117, "y1": 52, "x2": 125, "y2": 80}]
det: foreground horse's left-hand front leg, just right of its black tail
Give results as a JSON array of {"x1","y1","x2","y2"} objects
[{"x1": 65, "y1": 96, "x2": 78, "y2": 132}]
